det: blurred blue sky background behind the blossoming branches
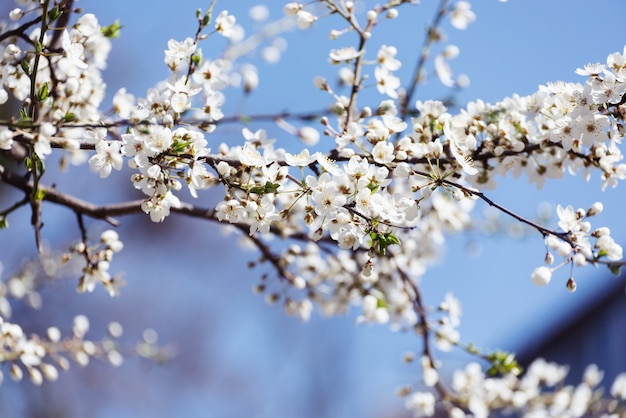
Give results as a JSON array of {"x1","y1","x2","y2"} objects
[{"x1": 0, "y1": 0, "x2": 626, "y2": 418}]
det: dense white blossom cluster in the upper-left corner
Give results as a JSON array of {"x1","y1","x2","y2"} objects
[{"x1": 0, "y1": 10, "x2": 111, "y2": 159}]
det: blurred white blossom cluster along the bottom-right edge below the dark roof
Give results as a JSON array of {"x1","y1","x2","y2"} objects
[{"x1": 406, "y1": 359, "x2": 626, "y2": 418}]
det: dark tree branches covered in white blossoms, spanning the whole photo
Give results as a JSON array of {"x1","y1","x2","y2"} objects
[{"x1": 0, "y1": 0, "x2": 626, "y2": 417}]
